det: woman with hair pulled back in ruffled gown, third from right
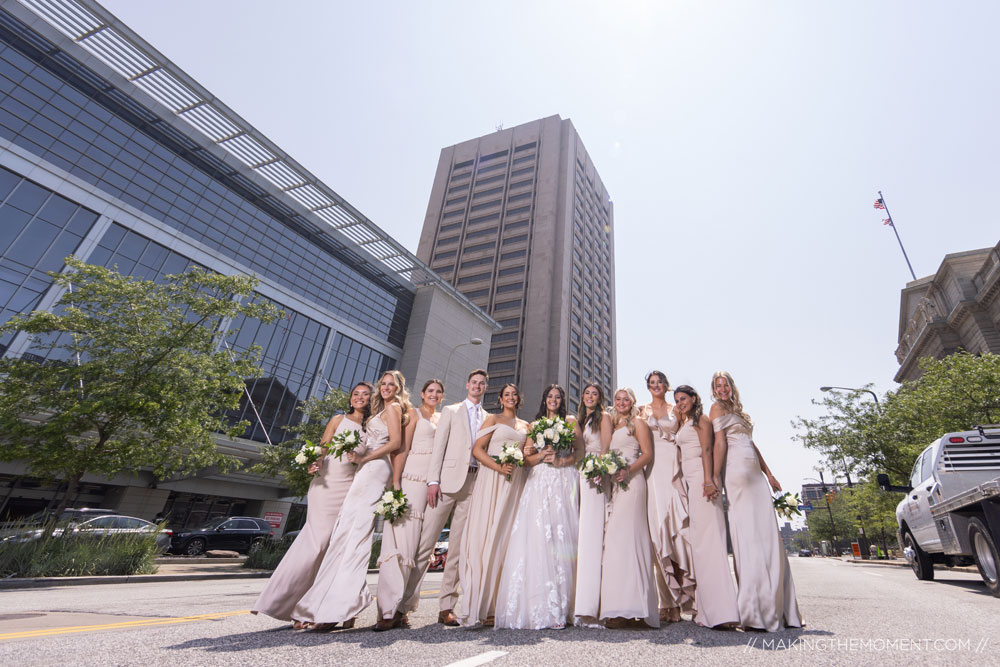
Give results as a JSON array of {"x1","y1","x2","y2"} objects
[{"x1": 641, "y1": 371, "x2": 694, "y2": 623}]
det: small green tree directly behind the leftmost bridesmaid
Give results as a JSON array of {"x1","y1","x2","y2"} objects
[{"x1": 250, "y1": 389, "x2": 349, "y2": 496}]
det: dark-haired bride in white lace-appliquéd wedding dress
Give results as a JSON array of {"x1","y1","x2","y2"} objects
[{"x1": 496, "y1": 384, "x2": 583, "y2": 630}]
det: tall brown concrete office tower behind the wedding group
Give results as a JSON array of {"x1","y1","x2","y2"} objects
[{"x1": 417, "y1": 116, "x2": 617, "y2": 416}]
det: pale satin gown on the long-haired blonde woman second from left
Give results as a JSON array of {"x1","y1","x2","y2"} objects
[{"x1": 292, "y1": 412, "x2": 392, "y2": 623}]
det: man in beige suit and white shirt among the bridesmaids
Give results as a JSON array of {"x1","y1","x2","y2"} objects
[{"x1": 404, "y1": 368, "x2": 489, "y2": 626}]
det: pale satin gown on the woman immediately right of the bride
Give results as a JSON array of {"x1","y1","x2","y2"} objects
[{"x1": 574, "y1": 422, "x2": 611, "y2": 625}]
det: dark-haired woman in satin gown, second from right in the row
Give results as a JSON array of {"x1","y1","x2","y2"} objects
[{"x1": 674, "y1": 385, "x2": 740, "y2": 628}]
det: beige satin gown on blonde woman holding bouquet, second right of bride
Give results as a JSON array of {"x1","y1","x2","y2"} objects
[{"x1": 601, "y1": 426, "x2": 660, "y2": 628}]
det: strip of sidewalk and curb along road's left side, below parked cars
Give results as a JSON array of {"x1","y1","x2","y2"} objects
[{"x1": 0, "y1": 557, "x2": 271, "y2": 590}]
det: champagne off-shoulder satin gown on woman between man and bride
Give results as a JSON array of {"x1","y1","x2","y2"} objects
[{"x1": 458, "y1": 424, "x2": 528, "y2": 627}]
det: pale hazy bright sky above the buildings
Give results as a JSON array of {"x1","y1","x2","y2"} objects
[{"x1": 104, "y1": 0, "x2": 1000, "y2": 504}]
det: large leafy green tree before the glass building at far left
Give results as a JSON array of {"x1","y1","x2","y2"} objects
[{"x1": 0, "y1": 257, "x2": 279, "y2": 511}]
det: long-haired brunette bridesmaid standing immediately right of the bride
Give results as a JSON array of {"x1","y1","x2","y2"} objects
[{"x1": 574, "y1": 383, "x2": 611, "y2": 627}]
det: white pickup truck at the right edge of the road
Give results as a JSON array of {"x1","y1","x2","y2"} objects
[{"x1": 878, "y1": 425, "x2": 1000, "y2": 597}]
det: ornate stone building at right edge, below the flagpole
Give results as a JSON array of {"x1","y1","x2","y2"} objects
[{"x1": 895, "y1": 244, "x2": 1000, "y2": 382}]
